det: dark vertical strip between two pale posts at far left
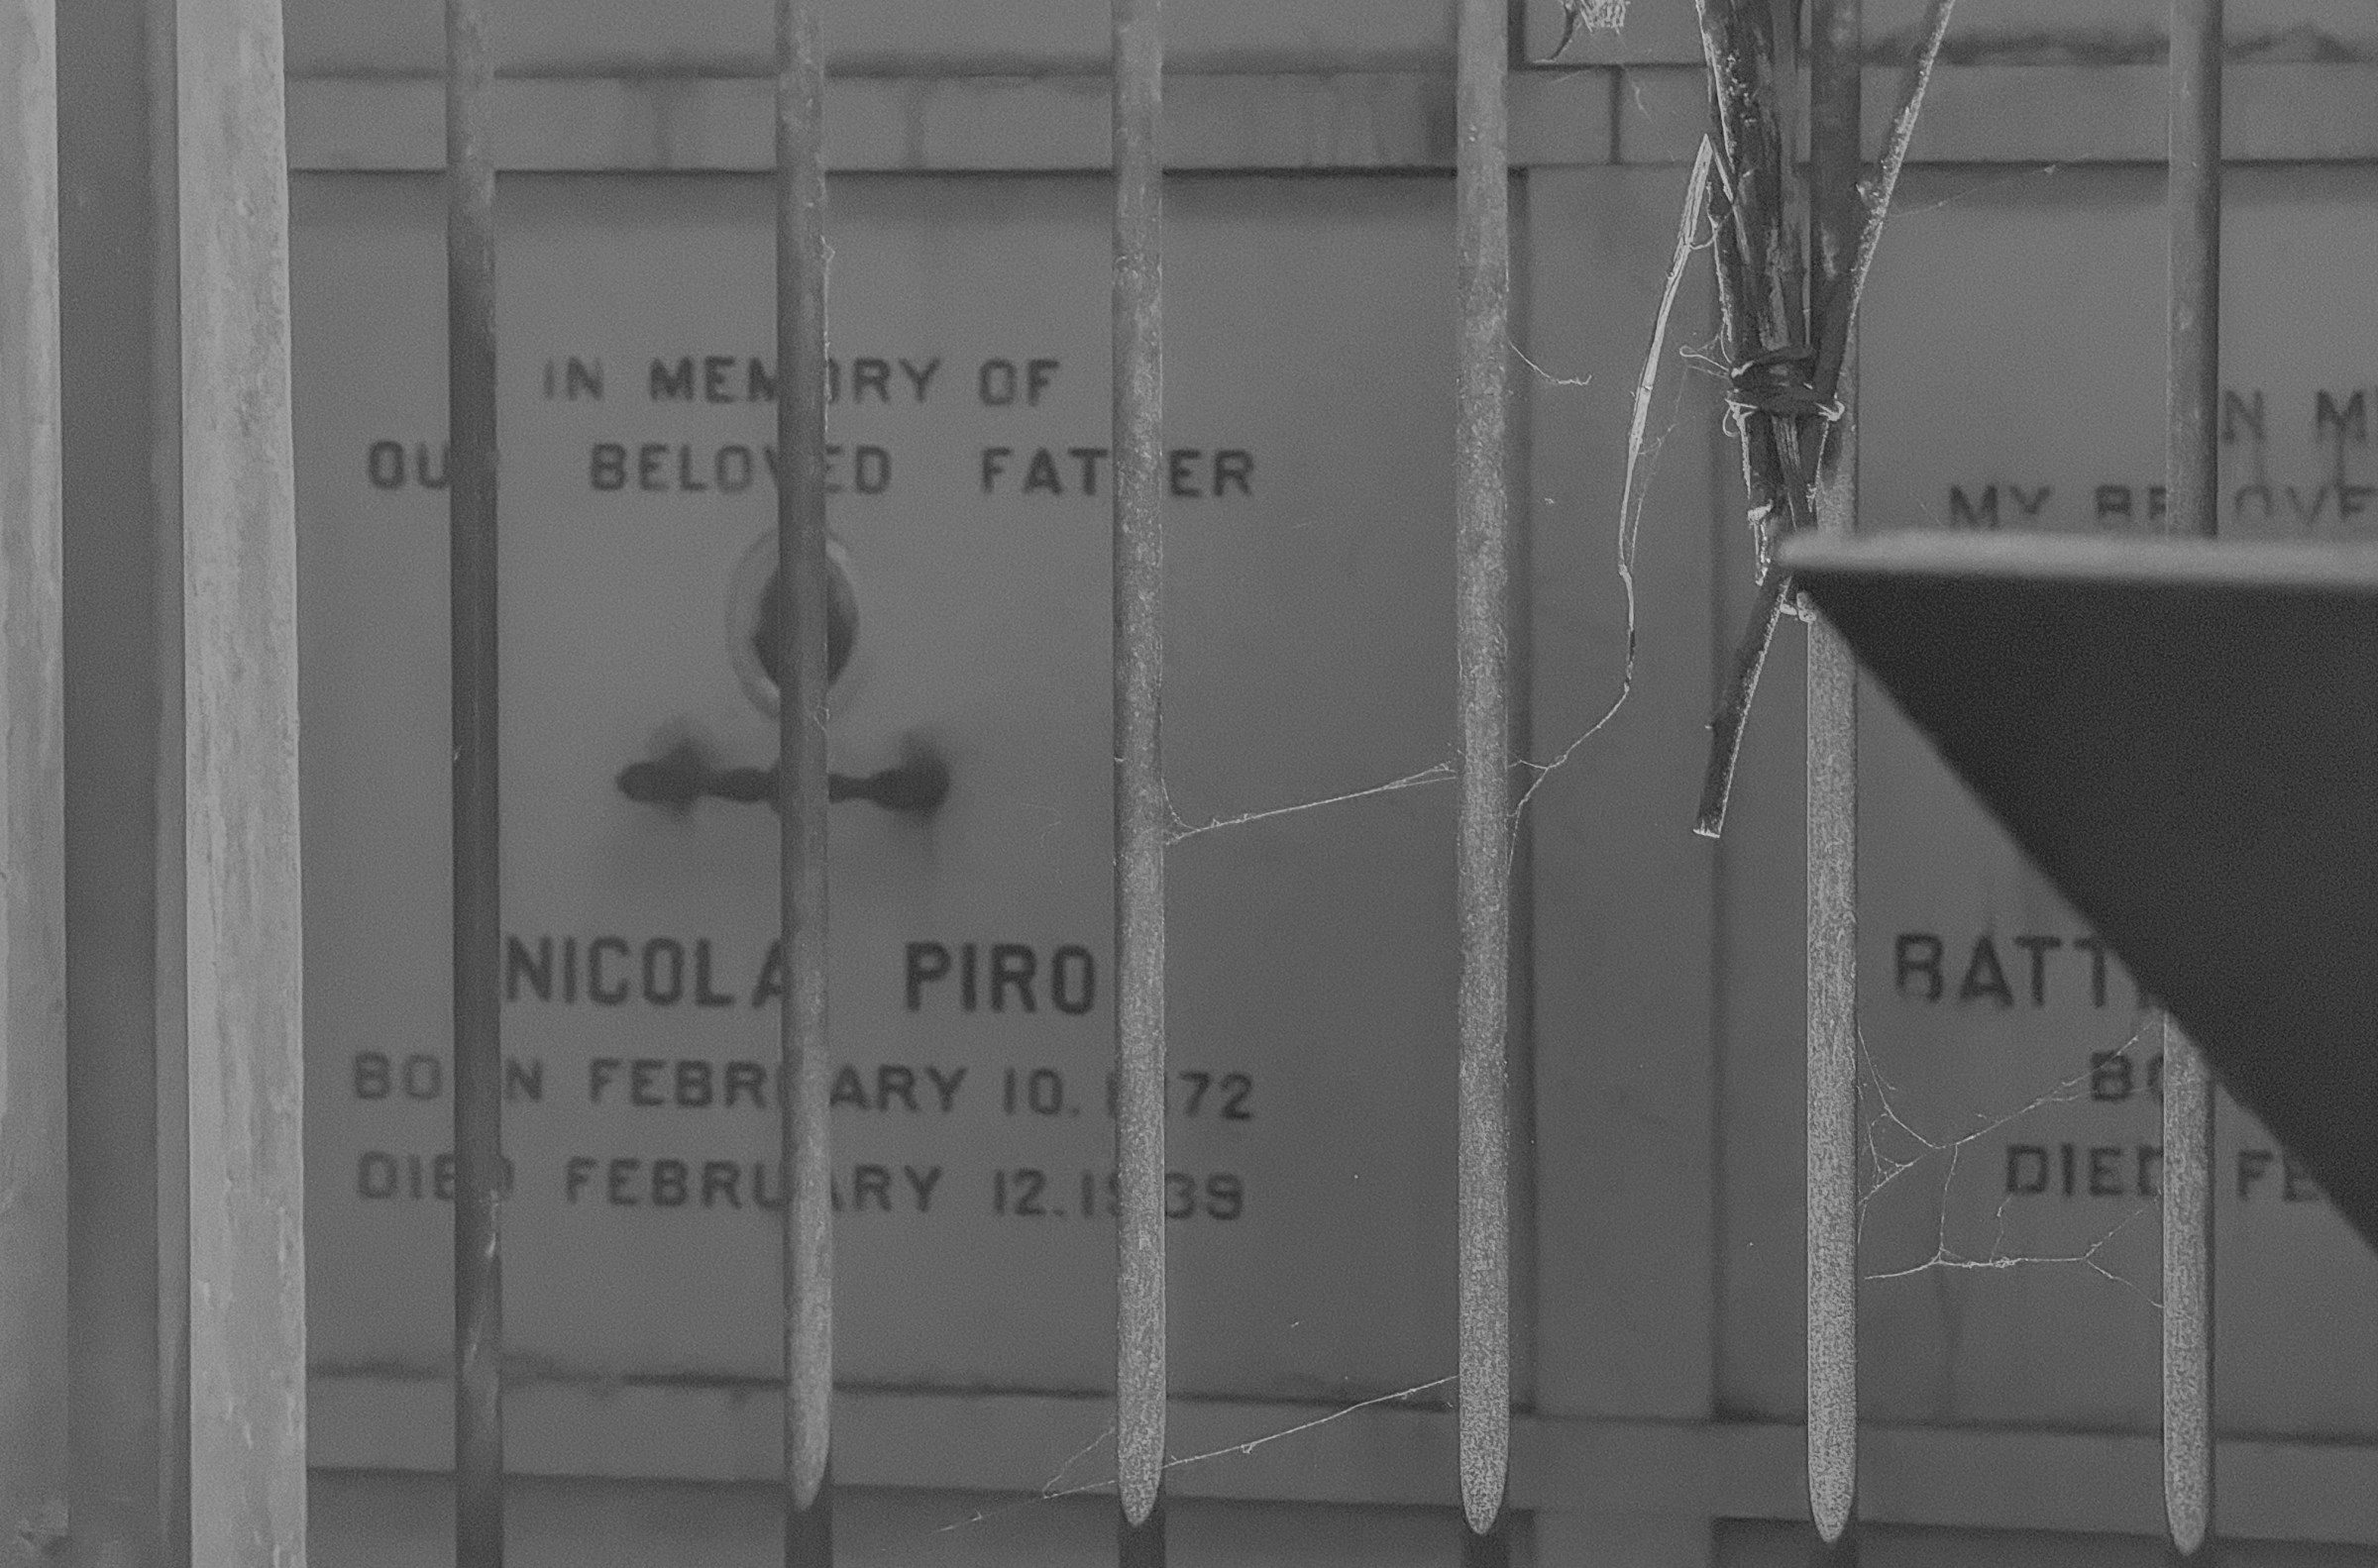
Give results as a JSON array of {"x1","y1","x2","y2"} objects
[{"x1": 57, "y1": 0, "x2": 190, "y2": 1568}]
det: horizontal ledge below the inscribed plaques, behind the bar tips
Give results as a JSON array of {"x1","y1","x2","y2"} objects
[{"x1": 311, "y1": 1366, "x2": 2378, "y2": 1546}]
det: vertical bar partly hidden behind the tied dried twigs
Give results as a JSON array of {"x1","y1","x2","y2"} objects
[{"x1": 1805, "y1": 0, "x2": 1867, "y2": 1544}]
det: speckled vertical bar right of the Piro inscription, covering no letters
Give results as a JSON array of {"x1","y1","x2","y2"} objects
[{"x1": 1453, "y1": 0, "x2": 1512, "y2": 1534}]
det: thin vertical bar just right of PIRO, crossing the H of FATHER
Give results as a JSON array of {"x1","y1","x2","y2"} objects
[{"x1": 1111, "y1": 0, "x2": 1165, "y2": 1566}]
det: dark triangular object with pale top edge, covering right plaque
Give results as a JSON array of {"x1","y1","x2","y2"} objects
[{"x1": 1784, "y1": 532, "x2": 2378, "y2": 1247}]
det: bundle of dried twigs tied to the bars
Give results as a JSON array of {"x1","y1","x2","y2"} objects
[{"x1": 1686, "y1": 0, "x2": 1955, "y2": 839}]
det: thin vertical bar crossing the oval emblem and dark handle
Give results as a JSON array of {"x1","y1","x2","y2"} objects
[{"x1": 775, "y1": 0, "x2": 834, "y2": 1568}]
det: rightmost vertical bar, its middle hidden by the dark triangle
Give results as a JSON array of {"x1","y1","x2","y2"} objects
[{"x1": 2157, "y1": 0, "x2": 2221, "y2": 1561}]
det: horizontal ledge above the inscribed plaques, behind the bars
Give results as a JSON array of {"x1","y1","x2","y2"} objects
[{"x1": 290, "y1": 61, "x2": 2378, "y2": 173}]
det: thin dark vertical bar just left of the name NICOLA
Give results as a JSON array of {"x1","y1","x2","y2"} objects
[{"x1": 447, "y1": 0, "x2": 504, "y2": 1568}]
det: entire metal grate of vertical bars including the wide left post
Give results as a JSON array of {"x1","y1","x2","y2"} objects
[{"x1": 10, "y1": 0, "x2": 2221, "y2": 1568}]
